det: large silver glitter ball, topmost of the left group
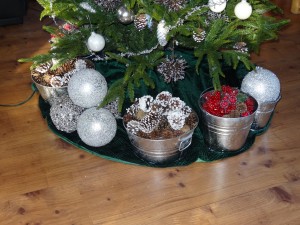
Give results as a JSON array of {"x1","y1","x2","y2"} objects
[{"x1": 68, "y1": 69, "x2": 107, "y2": 108}]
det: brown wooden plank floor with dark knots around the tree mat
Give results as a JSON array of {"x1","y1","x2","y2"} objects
[{"x1": 0, "y1": 0, "x2": 300, "y2": 225}]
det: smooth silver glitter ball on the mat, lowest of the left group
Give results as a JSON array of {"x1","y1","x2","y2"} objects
[{"x1": 77, "y1": 107, "x2": 117, "y2": 147}]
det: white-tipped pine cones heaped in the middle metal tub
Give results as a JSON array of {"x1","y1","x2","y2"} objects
[{"x1": 123, "y1": 91, "x2": 196, "y2": 139}]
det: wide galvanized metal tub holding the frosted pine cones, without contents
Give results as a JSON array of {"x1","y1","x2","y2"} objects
[{"x1": 124, "y1": 114, "x2": 199, "y2": 164}]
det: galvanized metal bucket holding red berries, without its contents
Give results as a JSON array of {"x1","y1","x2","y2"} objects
[{"x1": 199, "y1": 91, "x2": 257, "y2": 151}]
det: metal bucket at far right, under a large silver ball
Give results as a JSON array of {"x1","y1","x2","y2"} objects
[{"x1": 252, "y1": 96, "x2": 281, "y2": 130}]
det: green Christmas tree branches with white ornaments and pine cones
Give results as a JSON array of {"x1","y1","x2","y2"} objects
[{"x1": 20, "y1": 0, "x2": 288, "y2": 109}]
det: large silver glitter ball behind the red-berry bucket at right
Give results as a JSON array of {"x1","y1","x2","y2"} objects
[{"x1": 241, "y1": 67, "x2": 280, "y2": 103}]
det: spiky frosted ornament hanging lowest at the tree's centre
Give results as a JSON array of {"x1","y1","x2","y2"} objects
[{"x1": 157, "y1": 58, "x2": 187, "y2": 83}]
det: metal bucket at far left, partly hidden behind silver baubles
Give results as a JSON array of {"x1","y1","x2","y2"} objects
[{"x1": 32, "y1": 79, "x2": 68, "y2": 105}]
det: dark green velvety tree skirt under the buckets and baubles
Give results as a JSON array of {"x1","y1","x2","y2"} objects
[{"x1": 39, "y1": 54, "x2": 271, "y2": 167}]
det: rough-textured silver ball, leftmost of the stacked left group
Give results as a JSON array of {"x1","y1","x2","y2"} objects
[{"x1": 50, "y1": 95, "x2": 84, "y2": 133}]
